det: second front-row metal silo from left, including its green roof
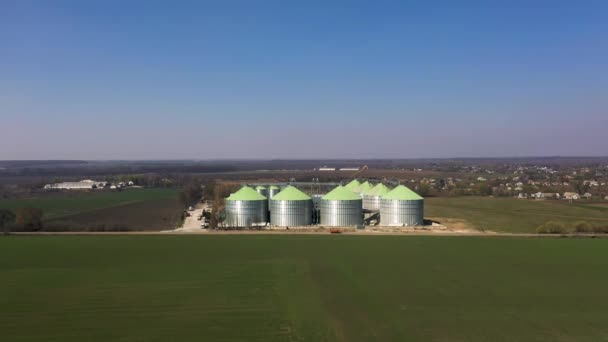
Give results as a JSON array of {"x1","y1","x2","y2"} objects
[{"x1": 270, "y1": 186, "x2": 313, "y2": 227}]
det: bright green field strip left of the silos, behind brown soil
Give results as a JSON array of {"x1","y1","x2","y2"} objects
[{"x1": 0, "y1": 188, "x2": 177, "y2": 219}]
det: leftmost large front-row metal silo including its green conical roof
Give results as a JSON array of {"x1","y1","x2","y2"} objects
[{"x1": 225, "y1": 186, "x2": 268, "y2": 227}]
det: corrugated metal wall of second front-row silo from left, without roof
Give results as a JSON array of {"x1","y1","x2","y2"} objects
[{"x1": 270, "y1": 200, "x2": 312, "y2": 227}]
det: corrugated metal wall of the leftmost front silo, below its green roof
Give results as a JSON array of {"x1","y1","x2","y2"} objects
[{"x1": 225, "y1": 200, "x2": 268, "y2": 227}]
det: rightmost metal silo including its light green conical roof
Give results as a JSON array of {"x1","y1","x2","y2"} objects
[{"x1": 380, "y1": 185, "x2": 424, "y2": 226}]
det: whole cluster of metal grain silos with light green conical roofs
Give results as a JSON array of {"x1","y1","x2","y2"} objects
[{"x1": 224, "y1": 180, "x2": 424, "y2": 228}]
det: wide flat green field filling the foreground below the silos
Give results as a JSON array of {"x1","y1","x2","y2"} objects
[{"x1": 0, "y1": 235, "x2": 608, "y2": 342}]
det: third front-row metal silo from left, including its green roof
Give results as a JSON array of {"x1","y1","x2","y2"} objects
[{"x1": 320, "y1": 186, "x2": 363, "y2": 227}]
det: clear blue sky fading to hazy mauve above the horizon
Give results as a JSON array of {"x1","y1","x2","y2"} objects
[{"x1": 0, "y1": 0, "x2": 608, "y2": 159}]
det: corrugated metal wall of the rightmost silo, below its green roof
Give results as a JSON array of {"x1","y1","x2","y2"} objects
[{"x1": 380, "y1": 199, "x2": 424, "y2": 226}]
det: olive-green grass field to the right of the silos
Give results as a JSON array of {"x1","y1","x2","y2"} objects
[{"x1": 425, "y1": 197, "x2": 608, "y2": 233}]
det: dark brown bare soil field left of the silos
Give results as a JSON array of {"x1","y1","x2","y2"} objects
[{"x1": 50, "y1": 199, "x2": 182, "y2": 230}]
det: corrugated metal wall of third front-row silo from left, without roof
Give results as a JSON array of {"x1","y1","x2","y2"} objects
[{"x1": 320, "y1": 199, "x2": 363, "y2": 227}]
